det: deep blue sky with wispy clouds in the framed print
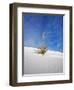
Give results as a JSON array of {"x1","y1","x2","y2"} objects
[{"x1": 23, "y1": 13, "x2": 63, "y2": 52}]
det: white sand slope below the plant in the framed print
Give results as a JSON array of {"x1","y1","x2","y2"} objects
[{"x1": 23, "y1": 47, "x2": 63, "y2": 75}]
